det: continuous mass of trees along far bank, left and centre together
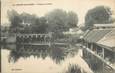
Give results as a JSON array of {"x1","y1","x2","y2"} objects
[{"x1": 8, "y1": 9, "x2": 78, "y2": 34}]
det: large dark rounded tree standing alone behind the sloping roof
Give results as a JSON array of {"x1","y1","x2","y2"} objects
[{"x1": 85, "y1": 6, "x2": 113, "y2": 29}]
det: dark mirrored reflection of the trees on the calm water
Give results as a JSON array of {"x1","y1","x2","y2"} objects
[{"x1": 9, "y1": 45, "x2": 78, "y2": 63}]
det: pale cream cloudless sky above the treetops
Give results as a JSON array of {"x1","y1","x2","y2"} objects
[{"x1": 1, "y1": 0, "x2": 115, "y2": 25}]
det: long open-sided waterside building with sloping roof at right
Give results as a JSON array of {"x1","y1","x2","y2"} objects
[{"x1": 82, "y1": 24, "x2": 115, "y2": 73}]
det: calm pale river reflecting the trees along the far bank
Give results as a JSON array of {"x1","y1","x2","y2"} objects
[{"x1": 1, "y1": 45, "x2": 93, "y2": 73}]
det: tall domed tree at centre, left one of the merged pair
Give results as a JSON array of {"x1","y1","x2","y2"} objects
[{"x1": 46, "y1": 9, "x2": 67, "y2": 32}]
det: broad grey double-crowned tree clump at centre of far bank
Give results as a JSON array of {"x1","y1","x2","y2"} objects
[{"x1": 46, "y1": 9, "x2": 78, "y2": 32}]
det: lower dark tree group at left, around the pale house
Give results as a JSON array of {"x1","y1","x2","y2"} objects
[{"x1": 8, "y1": 10, "x2": 47, "y2": 33}]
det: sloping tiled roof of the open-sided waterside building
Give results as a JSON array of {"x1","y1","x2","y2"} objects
[{"x1": 84, "y1": 29, "x2": 115, "y2": 52}]
